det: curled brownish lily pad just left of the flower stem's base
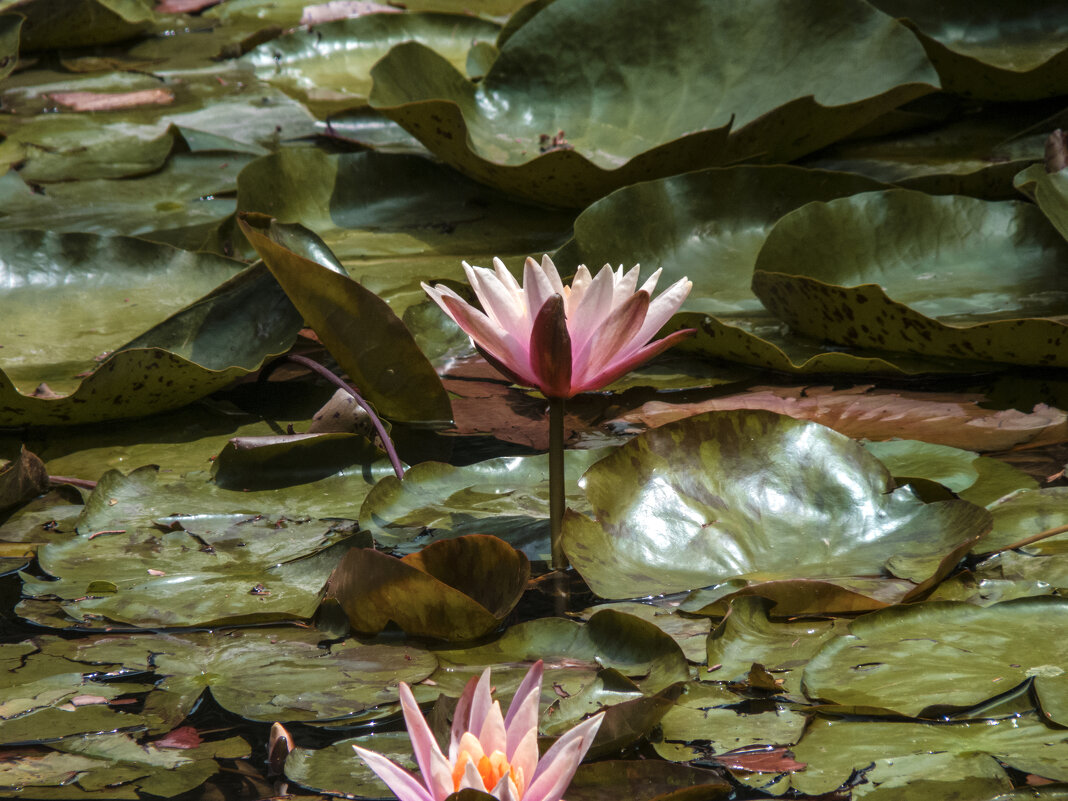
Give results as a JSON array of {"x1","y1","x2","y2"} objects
[{"x1": 330, "y1": 534, "x2": 530, "y2": 642}]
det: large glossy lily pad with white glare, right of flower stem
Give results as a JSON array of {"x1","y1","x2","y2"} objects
[{"x1": 564, "y1": 411, "x2": 989, "y2": 598}]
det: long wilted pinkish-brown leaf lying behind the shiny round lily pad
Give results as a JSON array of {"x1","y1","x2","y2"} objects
[{"x1": 613, "y1": 386, "x2": 1068, "y2": 452}]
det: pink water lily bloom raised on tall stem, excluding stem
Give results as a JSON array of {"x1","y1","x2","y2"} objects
[{"x1": 423, "y1": 256, "x2": 693, "y2": 398}]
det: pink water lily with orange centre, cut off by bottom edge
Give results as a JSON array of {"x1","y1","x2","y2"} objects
[{"x1": 352, "y1": 661, "x2": 604, "y2": 801}]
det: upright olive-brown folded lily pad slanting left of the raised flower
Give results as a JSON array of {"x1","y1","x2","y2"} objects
[{"x1": 240, "y1": 217, "x2": 452, "y2": 425}]
